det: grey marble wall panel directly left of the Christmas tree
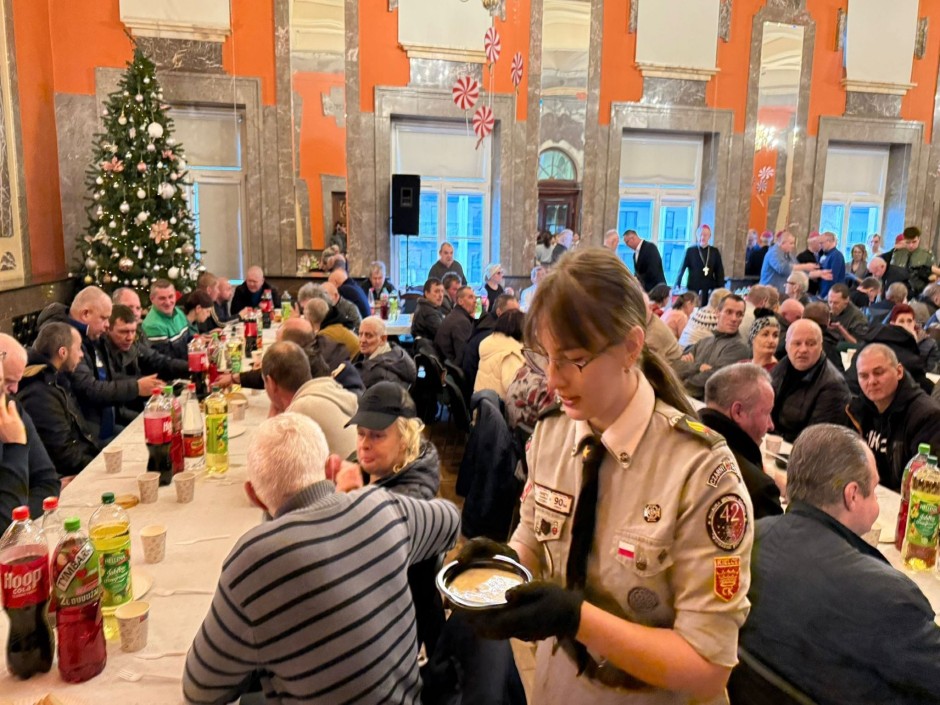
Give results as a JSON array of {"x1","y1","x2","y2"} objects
[{"x1": 55, "y1": 93, "x2": 101, "y2": 268}]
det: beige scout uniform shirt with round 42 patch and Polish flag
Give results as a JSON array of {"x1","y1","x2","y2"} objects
[{"x1": 512, "y1": 373, "x2": 753, "y2": 705}]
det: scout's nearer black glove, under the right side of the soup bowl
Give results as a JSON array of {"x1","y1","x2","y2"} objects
[{"x1": 467, "y1": 580, "x2": 584, "y2": 641}]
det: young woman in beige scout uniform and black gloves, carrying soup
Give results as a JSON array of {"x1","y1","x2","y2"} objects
[{"x1": 460, "y1": 248, "x2": 753, "y2": 705}]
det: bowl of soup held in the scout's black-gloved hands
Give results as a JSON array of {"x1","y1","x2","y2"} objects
[{"x1": 437, "y1": 556, "x2": 532, "y2": 610}]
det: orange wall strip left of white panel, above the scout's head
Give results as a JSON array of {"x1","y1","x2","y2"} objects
[{"x1": 598, "y1": 0, "x2": 643, "y2": 125}]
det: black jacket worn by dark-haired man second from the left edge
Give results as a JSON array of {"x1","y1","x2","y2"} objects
[{"x1": 17, "y1": 350, "x2": 101, "y2": 475}]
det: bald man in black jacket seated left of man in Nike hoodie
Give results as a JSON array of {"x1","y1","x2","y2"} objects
[{"x1": 771, "y1": 318, "x2": 852, "y2": 443}]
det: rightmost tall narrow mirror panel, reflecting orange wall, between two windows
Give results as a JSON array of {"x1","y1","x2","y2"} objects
[{"x1": 751, "y1": 22, "x2": 804, "y2": 232}]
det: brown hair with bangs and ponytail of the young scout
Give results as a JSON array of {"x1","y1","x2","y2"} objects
[{"x1": 525, "y1": 247, "x2": 694, "y2": 415}]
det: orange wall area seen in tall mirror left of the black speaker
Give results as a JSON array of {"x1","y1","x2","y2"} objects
[{"x1": 294, "y1": 73, "x2": 346, "y2": 249}]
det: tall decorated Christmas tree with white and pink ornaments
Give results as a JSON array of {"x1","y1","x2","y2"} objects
[{"x1": 77, "y1": 48, "x2": 204, "y2": 300}]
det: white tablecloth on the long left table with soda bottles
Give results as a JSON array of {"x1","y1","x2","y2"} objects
[{"x1": 0, "y1": 388, "x2": 273, "y2": 705}]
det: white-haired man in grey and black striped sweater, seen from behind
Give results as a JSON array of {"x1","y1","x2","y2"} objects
[{"x1": 183, "y1": 413, "x2": 460, "y2": 705}]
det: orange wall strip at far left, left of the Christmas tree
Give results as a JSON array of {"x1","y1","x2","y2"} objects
[{"x1": 13, "y1": 0, "x2": 66, "y2": 281}]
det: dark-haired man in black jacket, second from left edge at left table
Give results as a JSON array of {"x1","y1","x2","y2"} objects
[{"x1": 18, "y1": 321, "x2": 101, "y2": 475}]
